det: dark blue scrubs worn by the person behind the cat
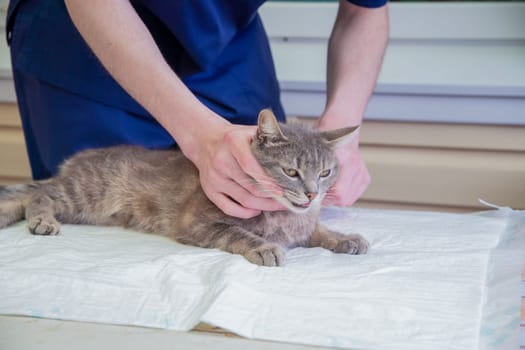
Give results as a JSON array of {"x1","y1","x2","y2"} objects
[{"x1": 6, "y1": 0, "x2": 386, "y2": 178}]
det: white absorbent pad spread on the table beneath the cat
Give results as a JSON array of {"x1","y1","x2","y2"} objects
[{"x1": 0, "y1": 208, "x2": 525, "y2": 350}]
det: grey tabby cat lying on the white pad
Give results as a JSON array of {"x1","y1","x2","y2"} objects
[{"x1": 0, "y1": 109, "x2": 368, "y2": 266}]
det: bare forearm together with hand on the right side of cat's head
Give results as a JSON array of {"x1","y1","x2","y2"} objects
[{"x1": 317, "y1": 0, "x2": 388, "y2": 206}]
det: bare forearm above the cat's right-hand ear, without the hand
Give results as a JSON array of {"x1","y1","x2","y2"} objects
[{"x1": 320, "y1": 0, "x2": 388, "y2": 129}]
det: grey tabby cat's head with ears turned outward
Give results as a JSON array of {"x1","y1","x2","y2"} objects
[{"x1": 252, "y1": 109, "x2": 358, "y2": 213}]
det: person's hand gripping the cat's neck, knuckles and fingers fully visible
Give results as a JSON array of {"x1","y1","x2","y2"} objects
[{"x1": 192, "y1": 124, "x2": 285, "y2": 219}]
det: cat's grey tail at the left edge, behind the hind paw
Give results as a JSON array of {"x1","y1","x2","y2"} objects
[{"x1": 0, "y1": 181, "x2": 47, "y2": 229}]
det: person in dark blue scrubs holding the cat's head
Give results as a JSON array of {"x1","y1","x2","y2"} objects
[{"x1": 6, "y1": 0, "x2": 388, "y2": 218}]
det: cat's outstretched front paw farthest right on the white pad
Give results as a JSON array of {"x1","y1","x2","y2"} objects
[{"x1": 306, "y1": 224, "x2": 368, "y2": 254}]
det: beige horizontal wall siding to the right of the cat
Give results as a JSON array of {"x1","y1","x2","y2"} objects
[{"x1": 344, "y1": 121, "x2": 525, "y2": 211}]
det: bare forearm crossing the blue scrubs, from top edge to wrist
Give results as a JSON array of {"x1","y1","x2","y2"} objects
[{"x1": 66, "y1": 0, "x2": 228, "y2": 155}]
